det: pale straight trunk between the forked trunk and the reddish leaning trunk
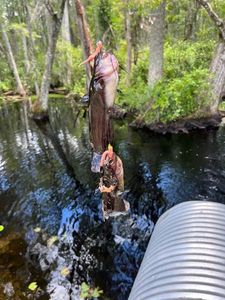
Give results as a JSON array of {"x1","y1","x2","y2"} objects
[{"x1": 62, "y1": 0, "x2": 72, "y2": 85}]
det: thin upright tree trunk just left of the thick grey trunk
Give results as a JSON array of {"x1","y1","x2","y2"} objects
[{"x1": 125, "y1": 4, "x2": 132, "y2": 86}]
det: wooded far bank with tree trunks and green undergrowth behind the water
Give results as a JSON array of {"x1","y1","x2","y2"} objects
[{"x1": 0, "y1": 0, "x2": 225, "y2": 133}]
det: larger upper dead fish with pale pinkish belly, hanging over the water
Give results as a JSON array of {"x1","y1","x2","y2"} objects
[{"x1": 82, "y1": 41, "x2": 119, "y2": 173}]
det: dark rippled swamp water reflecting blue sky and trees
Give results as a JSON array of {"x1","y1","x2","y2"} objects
[{"x1": 0, "y1": 100, "x2": 225, "y2": 300}]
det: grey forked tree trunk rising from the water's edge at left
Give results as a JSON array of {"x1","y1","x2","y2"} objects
[{"x1": 39, "y1": 0, "x2": 66, "y2": 112}]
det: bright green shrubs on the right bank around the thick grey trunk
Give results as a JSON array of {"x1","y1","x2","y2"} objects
[{"x1": 118, "y1": 42, "x2": 214, "y2": 123}]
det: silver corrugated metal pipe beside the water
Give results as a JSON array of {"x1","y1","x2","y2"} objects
[{"x1": 129, "y1": 201, "x2": 225, "y2": 300}]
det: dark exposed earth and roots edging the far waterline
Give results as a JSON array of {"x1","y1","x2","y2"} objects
[{"x1": 0, "y1": 88, "x2": 225, "y2": 134}]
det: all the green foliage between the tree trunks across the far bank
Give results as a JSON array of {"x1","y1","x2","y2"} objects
[{"x1": 0, "y1": 0, "x2": 221, "y2": 122}]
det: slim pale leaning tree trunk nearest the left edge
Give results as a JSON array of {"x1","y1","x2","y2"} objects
[{"x1": 0, "y1": 25, "x2": 26, "y2": 96}]
